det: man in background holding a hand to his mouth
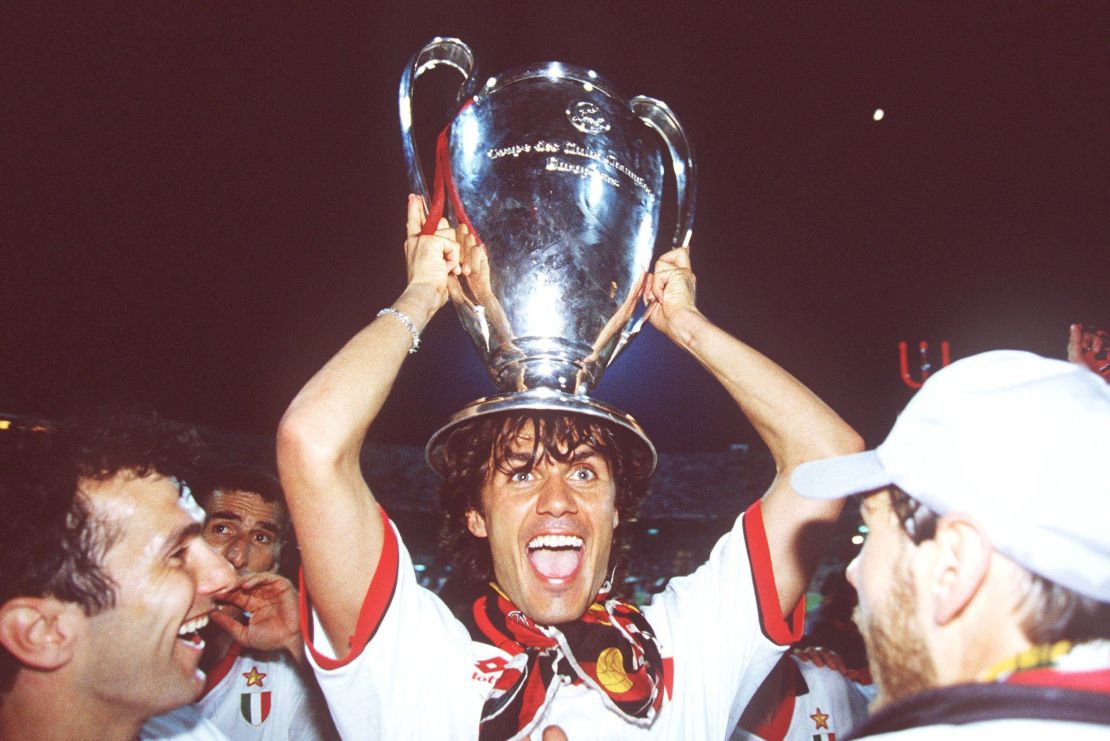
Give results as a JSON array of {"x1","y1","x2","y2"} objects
[{"x1": 143, "y1": 463, "x2": 335, "y2": 741}]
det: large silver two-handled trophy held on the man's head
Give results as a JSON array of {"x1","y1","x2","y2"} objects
[{"x1": 398, "y1": 38, "x2": 696, "y2": 470}]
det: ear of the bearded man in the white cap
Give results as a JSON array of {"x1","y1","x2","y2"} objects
[{"x1": 932, "y1": 516, "x2": 991, "y2": 626}]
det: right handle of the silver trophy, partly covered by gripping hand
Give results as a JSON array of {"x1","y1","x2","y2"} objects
[{"x1": 609, "y1": 95, "x2": 697, "y2": 354}]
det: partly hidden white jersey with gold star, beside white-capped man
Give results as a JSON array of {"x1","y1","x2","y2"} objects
[{"x1": 731, "y1": 656, "x2": 868, "y2": 741}]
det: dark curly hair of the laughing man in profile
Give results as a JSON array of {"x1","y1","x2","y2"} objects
[{"x1": 0, "y1": 410, "x2": 201, "y2": 691}]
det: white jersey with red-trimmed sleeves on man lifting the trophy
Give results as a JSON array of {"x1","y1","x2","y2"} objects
[{"x1": 301, "y1": 504, "x2": 801, "y2": 741}]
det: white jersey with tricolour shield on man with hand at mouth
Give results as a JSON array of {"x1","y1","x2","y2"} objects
[{"x1": 194, "y1": 643, "x2": 331, "y2": 741}]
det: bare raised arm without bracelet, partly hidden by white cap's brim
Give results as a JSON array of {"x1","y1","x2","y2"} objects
[{"x1": 645, "y1": 248, "x2": 864, "y2": 612}]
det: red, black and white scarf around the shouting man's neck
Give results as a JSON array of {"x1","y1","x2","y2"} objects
[{"x1": 473, "y1": 582, "x2": 663, "y2": 741}]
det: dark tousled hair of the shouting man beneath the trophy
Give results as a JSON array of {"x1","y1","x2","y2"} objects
[{"x1": 440, "y1": 410, "x2": 652, "y2": 589}]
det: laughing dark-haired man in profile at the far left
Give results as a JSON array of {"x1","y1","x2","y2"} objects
[{"x1": 0, "y1": 415, "x2": 234, "y2": 740}]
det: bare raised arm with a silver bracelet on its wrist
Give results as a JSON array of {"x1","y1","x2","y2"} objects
[{"x1": 278, "y1": 195, "x2": 461, "y2": 656}]
